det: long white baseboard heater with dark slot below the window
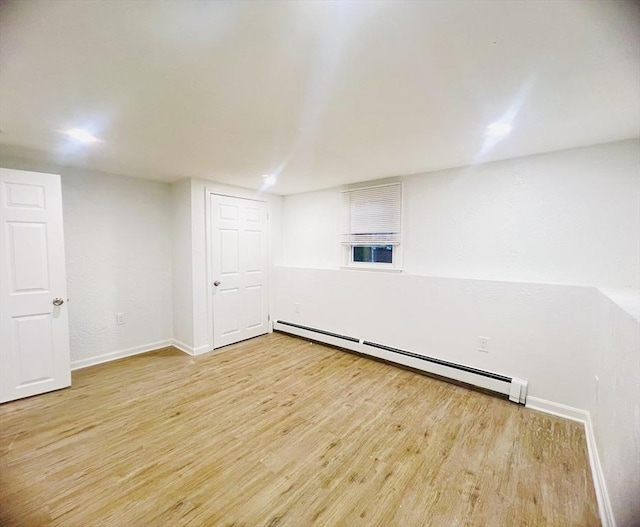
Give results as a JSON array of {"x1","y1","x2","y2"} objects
[{"x1": 273, "y1": 320, "x2": 527, "y2": 404}]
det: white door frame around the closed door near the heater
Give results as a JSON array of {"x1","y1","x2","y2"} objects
[{"x1": 204, "y1": 186, "x2": 273, "y2": 350}]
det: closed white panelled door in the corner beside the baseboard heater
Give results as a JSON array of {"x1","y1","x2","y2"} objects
[{"x1": 210, "y1": 194, "x2": 269, "y2": 348}]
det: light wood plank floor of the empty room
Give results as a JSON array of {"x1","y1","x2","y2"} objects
[{"x1": 0, "y1": 334, "x2": 599, "y2": 527}]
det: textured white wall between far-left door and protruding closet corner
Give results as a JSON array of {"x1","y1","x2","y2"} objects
[{"x1": 59, "y1": 169, "x2": 172, "y2": 362}]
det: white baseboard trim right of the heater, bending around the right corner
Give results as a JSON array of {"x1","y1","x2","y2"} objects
[{"x1": 526, "y1": 396, "x2": 616, "y2": 527}]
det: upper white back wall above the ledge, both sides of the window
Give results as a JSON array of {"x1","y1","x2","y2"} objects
[{"x1": 282, "y1": 140, "x2": 640, "y2": 288}]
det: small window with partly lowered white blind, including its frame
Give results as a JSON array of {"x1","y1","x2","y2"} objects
[{"x1": 342, "y1": 183, "x2": 402, "y2": 269}]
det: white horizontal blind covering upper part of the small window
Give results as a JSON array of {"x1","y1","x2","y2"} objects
[{"x1": 342, "y1": 183, "x2": 402, "y2": 245}]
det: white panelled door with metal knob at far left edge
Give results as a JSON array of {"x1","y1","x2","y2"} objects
[{"x1": 0, "y1": 168, "x2": 71, "y2": 402}]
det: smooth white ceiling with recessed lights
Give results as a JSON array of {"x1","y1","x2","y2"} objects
[{"x1": 0, "y1": 0, "x2": 640, "y2": 194}]
